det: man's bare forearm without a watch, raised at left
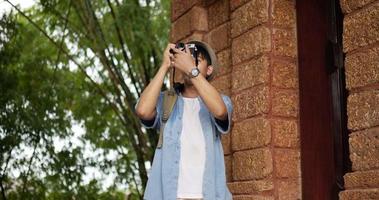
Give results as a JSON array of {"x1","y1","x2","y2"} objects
[{"x1": 136, "y1": 66, "x2": 169, "y2": 119}]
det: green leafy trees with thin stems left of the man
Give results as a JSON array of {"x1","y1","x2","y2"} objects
[{"x1": 0, "y1": 0, "x2": 170, "y2": 199}]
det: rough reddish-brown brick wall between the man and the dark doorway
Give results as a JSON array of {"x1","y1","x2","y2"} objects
[{"x1": 170, "y1": 0, "x2": 301, "y2": 200}]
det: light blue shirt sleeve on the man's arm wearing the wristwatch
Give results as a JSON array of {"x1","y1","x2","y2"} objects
[{"x1": 212, "y1": 94, "x2": 233, "y2": 134}]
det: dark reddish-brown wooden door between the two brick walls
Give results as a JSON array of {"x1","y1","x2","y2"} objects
[{"x1": 296, "y1": 0, "x2": 351, "y2": 200}]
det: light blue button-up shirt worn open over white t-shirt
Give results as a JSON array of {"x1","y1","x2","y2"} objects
[{"x1": 135, "y1": 92, "x2": 233, "y2": 200}]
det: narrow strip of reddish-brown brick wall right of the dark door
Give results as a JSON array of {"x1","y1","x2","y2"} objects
[{"x1": 340, "y1": 0, "x2": 379, "y2": 200}]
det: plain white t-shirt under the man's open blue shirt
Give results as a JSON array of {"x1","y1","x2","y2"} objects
[{"x1": 177, "y1": 96, "x2": 205, "y2": 198}]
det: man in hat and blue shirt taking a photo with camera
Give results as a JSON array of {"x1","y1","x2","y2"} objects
[{"x1": 135, "y1": 41, "x2": 233, "y2": 200}]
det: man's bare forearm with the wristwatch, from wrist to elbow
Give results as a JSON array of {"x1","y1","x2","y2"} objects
[{"x1": 191, "y1": 74, "x2": 227, "y2": 120}]
